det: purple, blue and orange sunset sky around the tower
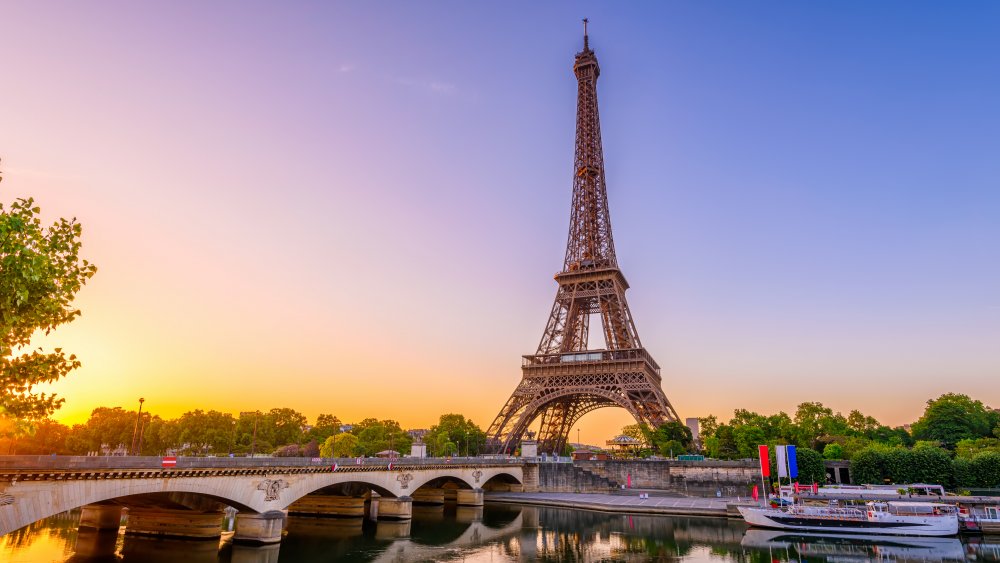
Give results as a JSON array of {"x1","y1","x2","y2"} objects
[{"x1": 0, "y1": 1, "x2": 1000, "y2": 443}]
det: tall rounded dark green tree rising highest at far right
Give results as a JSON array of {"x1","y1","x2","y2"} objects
[{"x1": 913, "y1": 393, "x2": 998, "y2": 450}]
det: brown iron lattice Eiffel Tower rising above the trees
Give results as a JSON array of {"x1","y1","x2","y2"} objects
[{"x1": 487, "y1": 23, "x2": 679, "y2": 453}]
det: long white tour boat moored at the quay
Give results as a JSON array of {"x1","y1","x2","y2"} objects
[{"x1": 739, "y1": 501, "x2": 958, "y2": 536}]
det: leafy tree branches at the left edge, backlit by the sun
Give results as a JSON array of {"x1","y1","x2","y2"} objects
[{"x1": 0, "y1": 191, "x2": 97, "y2": 420}]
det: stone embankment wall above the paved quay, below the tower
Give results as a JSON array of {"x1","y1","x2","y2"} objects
[{"x1": 568, "y1": 460, "x2": 760, "y2": 496}]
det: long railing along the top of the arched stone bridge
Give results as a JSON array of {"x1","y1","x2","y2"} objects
[{"x1": 0, "y1": 455, "x2": 522, "y2": 471}]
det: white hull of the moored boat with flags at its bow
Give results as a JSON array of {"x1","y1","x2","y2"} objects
[{"x1": 739, "y1": 506, "x2": 958, "y2": 536}]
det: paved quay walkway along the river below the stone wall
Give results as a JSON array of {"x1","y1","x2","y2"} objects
[{"x1": 486, "y1": 493, "x2": 752, "y2": 516}]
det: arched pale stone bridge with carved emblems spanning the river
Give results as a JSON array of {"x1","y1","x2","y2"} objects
[{"x1": 0, "y1": 456, "x2": 525, "y2": 543}]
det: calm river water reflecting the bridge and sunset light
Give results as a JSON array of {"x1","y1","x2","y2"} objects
[{"x1": 0, "y1": 504, "x2": 1000, "y2": 563}]
